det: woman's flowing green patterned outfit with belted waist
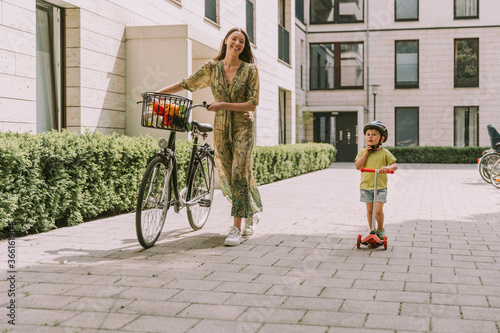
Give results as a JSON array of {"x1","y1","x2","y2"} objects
[{"x1": 181, "y1": 60, "x2": 262, "y2": 218}]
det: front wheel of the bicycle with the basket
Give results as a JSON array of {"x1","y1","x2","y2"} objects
[{"x1": 135, "y1": 156, "x2": 172, "y2": 249}]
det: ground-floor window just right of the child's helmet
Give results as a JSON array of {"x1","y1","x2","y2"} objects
[{"x1": 396, "y1": 107, "x2": 418, "y2": 147}]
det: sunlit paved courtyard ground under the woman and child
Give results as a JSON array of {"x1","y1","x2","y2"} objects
[{"x1": 0, "y1": 163, "x2": 500, "y2": 333}]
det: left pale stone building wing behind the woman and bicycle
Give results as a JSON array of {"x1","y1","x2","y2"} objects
[{"x1": 0, "y1": 0, "x2": 295, "y2": 145}]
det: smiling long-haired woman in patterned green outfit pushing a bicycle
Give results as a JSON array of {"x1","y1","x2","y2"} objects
[{"x1": 158, "y1": 28, "x2": 262, "y2": 246}]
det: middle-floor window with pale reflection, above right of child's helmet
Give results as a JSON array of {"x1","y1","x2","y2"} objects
[{"x1": 395, "y1": 40, "x2": 418, "y2": 88}]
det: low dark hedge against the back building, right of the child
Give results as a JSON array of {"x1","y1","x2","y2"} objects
[{"x1": 385, "y1": 146, "x2": 487, "y2": 164}]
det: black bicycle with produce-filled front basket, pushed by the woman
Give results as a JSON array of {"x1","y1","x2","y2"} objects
[{"x1": 136, "y1": 92, "x2": 214, "y2": 249}]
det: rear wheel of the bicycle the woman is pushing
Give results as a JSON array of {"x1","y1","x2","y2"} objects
[{"x1": 186, "y1": 153, "x2": 214, "y2": 230}]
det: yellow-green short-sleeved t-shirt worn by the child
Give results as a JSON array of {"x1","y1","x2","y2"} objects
[{"x1": 354, "y1": 148, "x2": 396, "y2": 190}]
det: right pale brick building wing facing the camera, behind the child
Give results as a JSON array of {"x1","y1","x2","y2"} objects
[{"x1": 295, "y1": 0, "x2": 500, "y2": 161}]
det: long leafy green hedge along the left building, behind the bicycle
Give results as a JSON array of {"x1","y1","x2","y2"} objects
[{"x1": 0, "y1": 131, "x2": 335, "y2": 234}]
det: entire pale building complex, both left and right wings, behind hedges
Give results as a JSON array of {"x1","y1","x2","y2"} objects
[{"x1": 0, "y1": 0, "x2": 500, "y2": 161}]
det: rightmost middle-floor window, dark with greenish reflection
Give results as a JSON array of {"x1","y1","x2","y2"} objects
[{"x1": 455, "y1": 38, "x2": 479, "y2": 88}]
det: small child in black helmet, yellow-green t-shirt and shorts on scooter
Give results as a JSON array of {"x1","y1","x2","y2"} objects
[{"x1": 354, "y1": 120, "x2": 398, "y2": 239}]
